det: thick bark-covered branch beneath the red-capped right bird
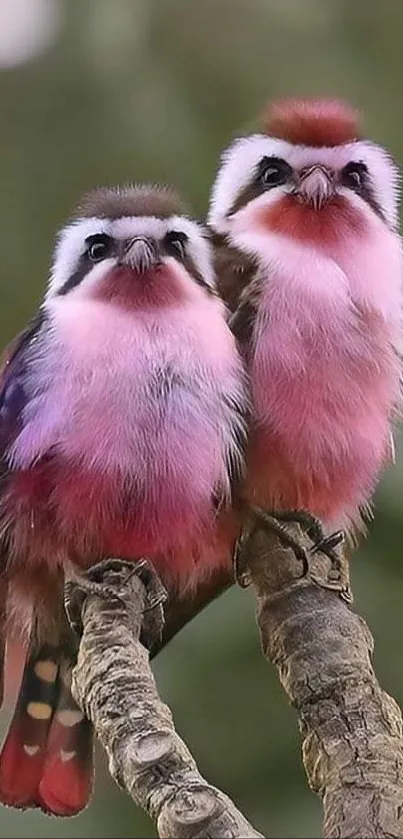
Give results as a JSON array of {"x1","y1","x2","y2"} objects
[{"x1": 240, "y1": 528, "x2": 403, "y2": 839}]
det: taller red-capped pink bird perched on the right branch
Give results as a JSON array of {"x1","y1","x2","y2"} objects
[{"x1": 207, "y1": 98, "x2": 403, "y2": 572}]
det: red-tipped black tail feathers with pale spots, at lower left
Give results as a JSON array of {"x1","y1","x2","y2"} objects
[{"x1": 0, "y1": 645, "x2": 93, "y2": 816}]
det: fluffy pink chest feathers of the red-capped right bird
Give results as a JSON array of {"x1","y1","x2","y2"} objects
[{"x1": 249, "y1": 233, "x2": 401, "y2": 526}]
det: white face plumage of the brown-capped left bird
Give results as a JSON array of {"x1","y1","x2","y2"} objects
[{"x1": 47, "y1": 216, "x2": 215, "y2": 299}]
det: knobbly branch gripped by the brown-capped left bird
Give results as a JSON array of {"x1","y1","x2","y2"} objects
[{"x1": 67, "y1": 566, "x2": 262, "y2": 839}]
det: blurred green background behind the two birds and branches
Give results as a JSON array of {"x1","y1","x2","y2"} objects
[{"x1": 0, "y1": 0, "x2": 403, "y2": 839}]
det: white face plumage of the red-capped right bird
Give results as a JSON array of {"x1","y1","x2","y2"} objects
[{"x1": 208, "y1": 134, "x2": 399, "y2": 233}]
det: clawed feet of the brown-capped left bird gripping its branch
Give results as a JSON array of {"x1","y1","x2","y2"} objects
[{"x1": 64, "y1": 559, "x2": 167, "y2": 649}]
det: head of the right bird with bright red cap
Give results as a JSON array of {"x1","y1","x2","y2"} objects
[{"x1": 209, "y1": 99, "x2": 399, "y2": 245}]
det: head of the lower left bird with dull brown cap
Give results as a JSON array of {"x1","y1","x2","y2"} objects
[{"x1": 47, "y1": 186, "x2": 215, "y2": 309}]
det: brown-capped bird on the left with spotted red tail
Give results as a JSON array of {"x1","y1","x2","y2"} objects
[{"x1": 0, "y1": 184, "x2": 248, "y2": 816}]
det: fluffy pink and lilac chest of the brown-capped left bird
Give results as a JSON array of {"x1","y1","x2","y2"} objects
[{"x1": 10, "y1": 298, "x2": 244, "y2": 572}]
